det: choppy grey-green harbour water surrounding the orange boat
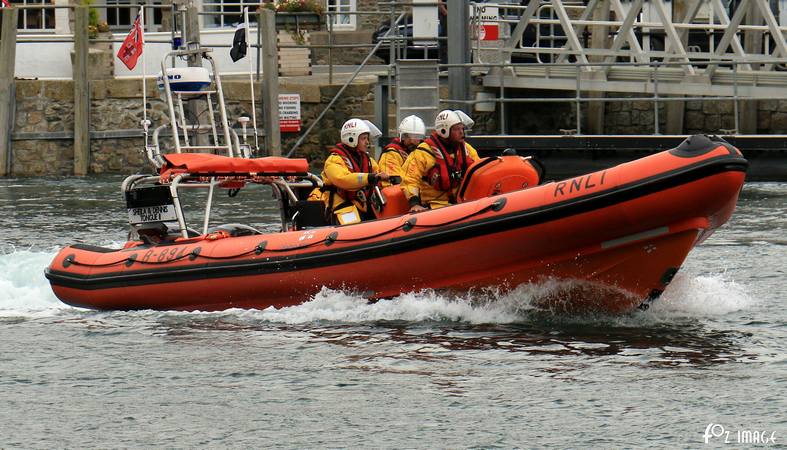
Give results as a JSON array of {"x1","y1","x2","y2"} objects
[{"x1": 0, "y1": 178, "x2": 787, "y2": 448}]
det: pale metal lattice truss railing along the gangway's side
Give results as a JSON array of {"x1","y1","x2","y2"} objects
[{"x1": 472, "y1": 0, "x2": 787, "y2": 78}]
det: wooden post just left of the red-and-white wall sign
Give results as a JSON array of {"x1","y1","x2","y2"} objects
[{"x1": 258, "y1": 8, "x2": 281, "y2": 156}]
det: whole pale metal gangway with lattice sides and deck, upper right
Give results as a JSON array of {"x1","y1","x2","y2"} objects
[{"x1": 484, "y1": 0, "x2": 787, "y2": 99}]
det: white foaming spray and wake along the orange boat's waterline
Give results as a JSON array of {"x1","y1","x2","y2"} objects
[{"x1": 0, "y1": 250, "x2": 754, "y2": 324}]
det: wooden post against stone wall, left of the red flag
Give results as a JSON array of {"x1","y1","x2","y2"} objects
[{"x1": 74, "y1": 6, "x2": 90, "y2": 176}]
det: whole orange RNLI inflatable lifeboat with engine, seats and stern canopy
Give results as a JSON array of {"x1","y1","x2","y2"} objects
[{"x1": 46, "y1": 135, "x2": 748, "y2": 313}]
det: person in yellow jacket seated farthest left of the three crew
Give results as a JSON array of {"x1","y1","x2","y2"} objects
[{"x1": 322, "y1": 119, "x2": 389, "y2": 225}]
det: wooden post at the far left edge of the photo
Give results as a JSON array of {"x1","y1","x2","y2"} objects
[{"x1": 0, "y1": 8, "x2": 18, "y2": 177}]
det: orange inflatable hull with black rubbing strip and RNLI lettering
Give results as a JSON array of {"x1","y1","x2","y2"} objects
[{"x1": 47, "y1": 139, "x2": 747, "y2": 313}]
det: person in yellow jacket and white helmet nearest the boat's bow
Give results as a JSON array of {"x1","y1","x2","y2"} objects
[{"x1": 402, "y1": 109, "x2": 479, "y2": 212}]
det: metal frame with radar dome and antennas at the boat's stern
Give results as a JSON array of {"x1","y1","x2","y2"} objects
[{"x1": 122, "y1": 42, "x2": 330, "y2": 238}]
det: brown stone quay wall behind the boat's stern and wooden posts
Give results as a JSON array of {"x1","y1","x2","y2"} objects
[{"x1": 10, "y1": 77, "x2": 388, "y2": 176}]
